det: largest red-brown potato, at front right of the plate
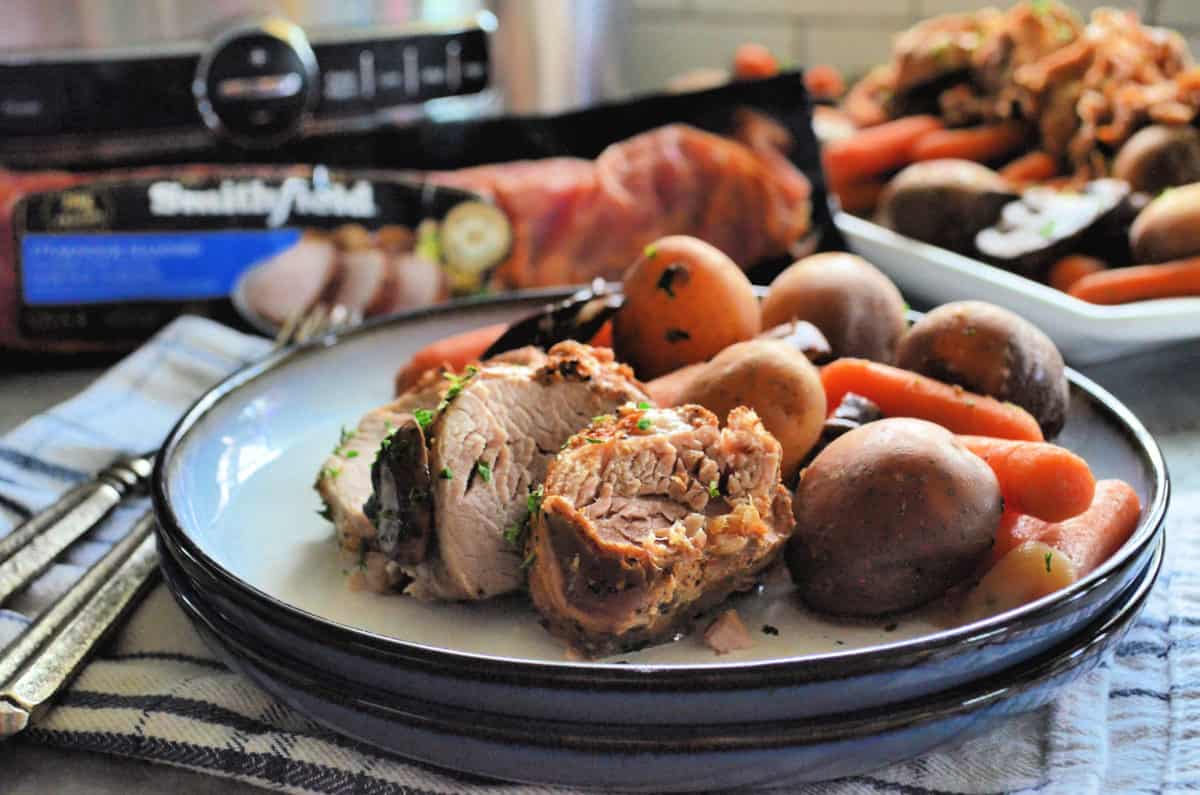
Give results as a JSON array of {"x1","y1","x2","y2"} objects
[{"x1": 786, "y1": 418, "x2": 1003, "y2": 616}]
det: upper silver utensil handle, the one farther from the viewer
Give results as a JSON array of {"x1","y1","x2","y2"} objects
[{"x1": 0, "y1": 458, "x2": 152, "y2": 605}]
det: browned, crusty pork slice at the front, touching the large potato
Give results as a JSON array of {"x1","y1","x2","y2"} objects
[{"x1": 527, "y1": 406, "x2": 794, "y2": 657}]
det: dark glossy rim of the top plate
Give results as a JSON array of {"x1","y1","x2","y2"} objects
[{"x1": 151, "y1": 286, "x2": 1170, "y2": 689}]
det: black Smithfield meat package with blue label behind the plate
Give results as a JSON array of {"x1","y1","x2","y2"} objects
[{"x1": 0, "y1": 73, "x2": 838, "y2": 351}]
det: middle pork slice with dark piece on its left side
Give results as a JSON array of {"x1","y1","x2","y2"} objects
[{"x1": 367, "y1": 341, "x2": 647, "y2": 600}]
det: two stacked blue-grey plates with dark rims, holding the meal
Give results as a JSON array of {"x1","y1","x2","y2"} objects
[{"x1": 155, "y1": 292, "x2": 1168, "y2": 791}]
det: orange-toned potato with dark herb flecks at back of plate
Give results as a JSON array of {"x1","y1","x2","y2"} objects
[{"x1": 612, "y1": 235, "x2": 761, "y2": 379}]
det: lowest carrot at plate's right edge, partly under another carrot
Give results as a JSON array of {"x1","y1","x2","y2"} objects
[{"x1": 992, "y1": 480, "x2": 1141, "y2": 575}]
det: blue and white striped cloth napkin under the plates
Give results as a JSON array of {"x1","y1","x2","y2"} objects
[{"x1": 0, "y1": 318, "x2": 1200, "y2": 795}]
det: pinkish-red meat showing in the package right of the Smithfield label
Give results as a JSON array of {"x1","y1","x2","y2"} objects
[{"x1": 431, "y1": 121, "x2": 811, "y2": 287}]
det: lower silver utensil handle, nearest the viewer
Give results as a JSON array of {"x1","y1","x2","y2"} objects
[{"x1": 0, "y1": 512, "x2": 158, "y2": 739}]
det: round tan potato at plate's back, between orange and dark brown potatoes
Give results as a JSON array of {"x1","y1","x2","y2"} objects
[{"x1": 762, "y1": 251, "x2": 907, "y2": 364}]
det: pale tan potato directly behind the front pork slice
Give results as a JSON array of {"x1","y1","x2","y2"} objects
[{"x1": 680, "y1": 339, "x2": 826, "y2": 482}]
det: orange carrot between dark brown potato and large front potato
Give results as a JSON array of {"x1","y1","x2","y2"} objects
[{"x1": 821, "y1": 358, "x2": 1043, "y2": 442}]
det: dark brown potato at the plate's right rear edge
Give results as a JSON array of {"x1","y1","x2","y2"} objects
[{"x1": 896, "y1": 301, "x2": 1070, "y2": 438}]
